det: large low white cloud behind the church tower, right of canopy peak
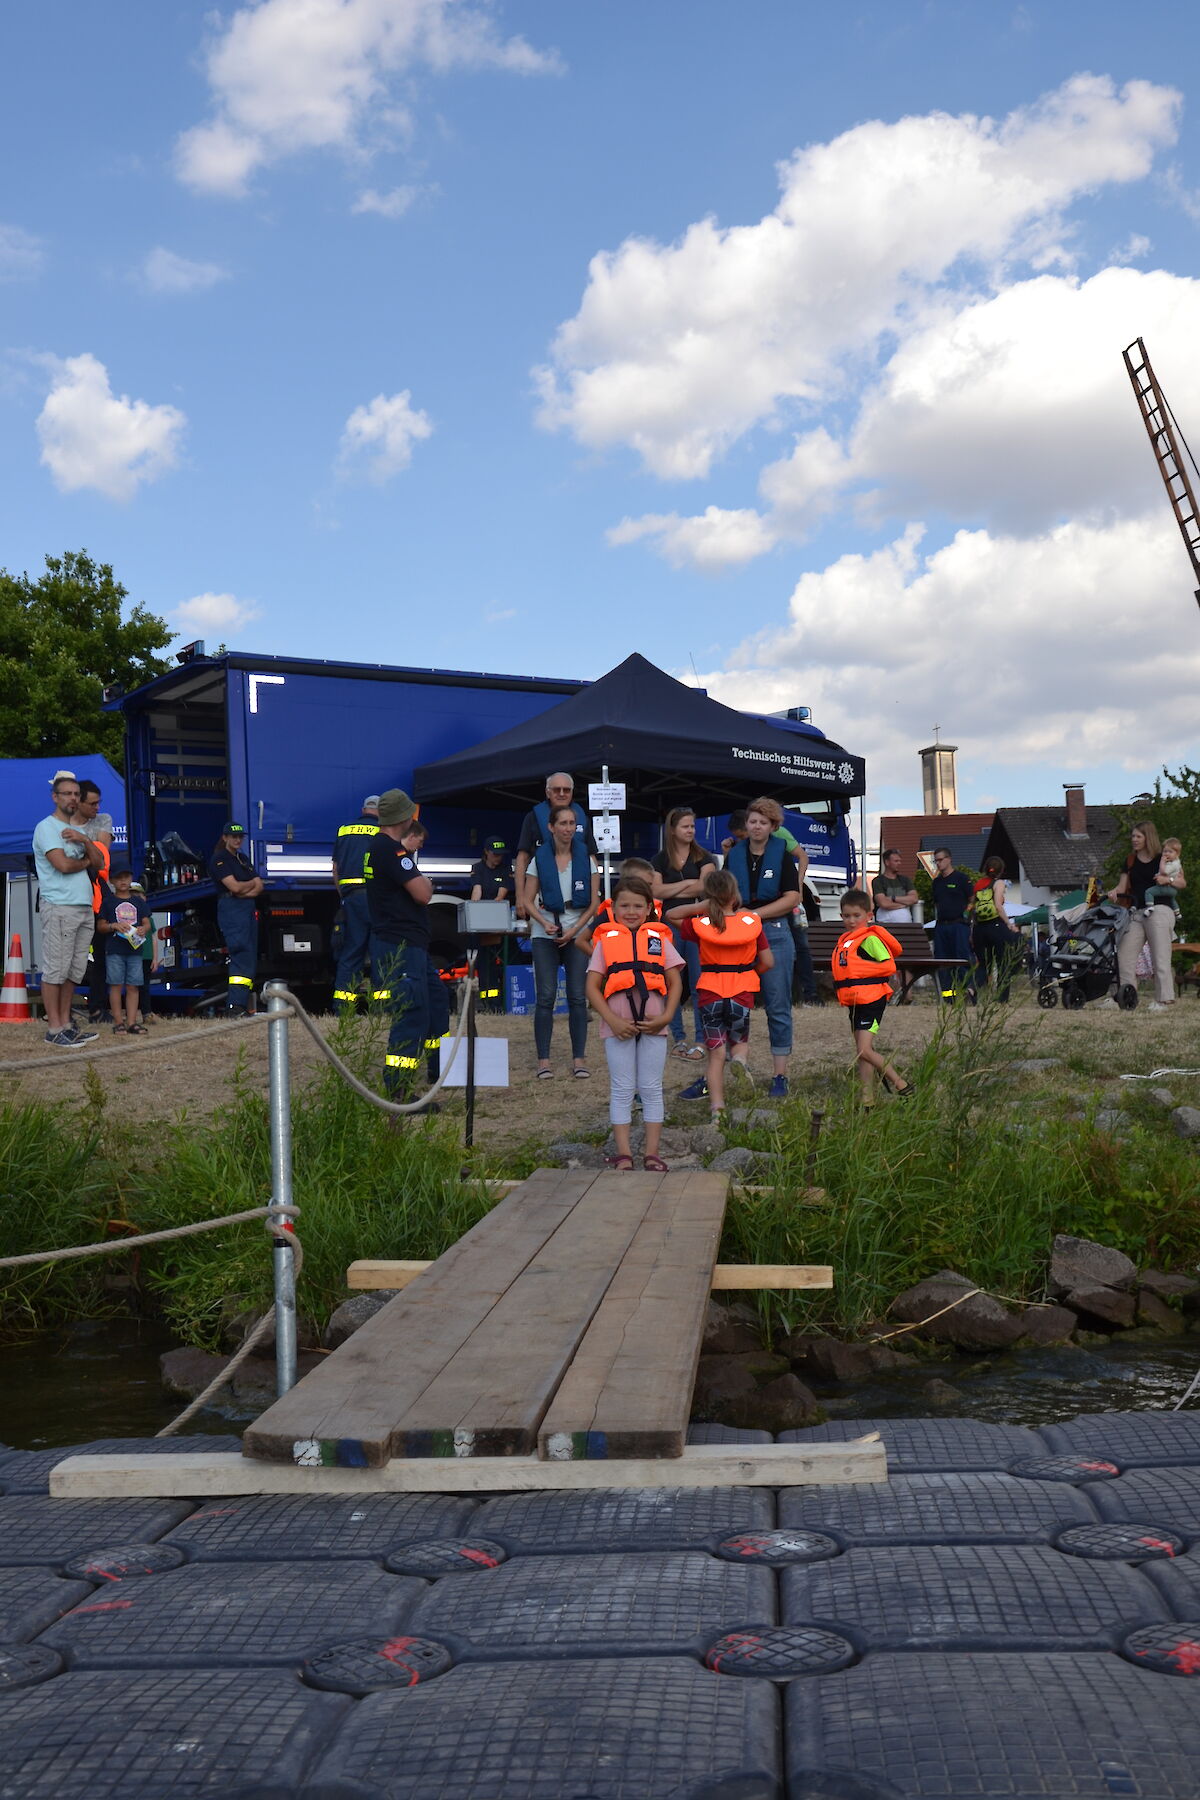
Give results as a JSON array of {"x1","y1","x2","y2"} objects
[{"x1": 700, "y1": 502, "x2": 1200, "y2": 785}]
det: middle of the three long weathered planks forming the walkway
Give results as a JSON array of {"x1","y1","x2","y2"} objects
[{"x1": 390, "y1": 1172, "x2": 665, "y2": 1458}]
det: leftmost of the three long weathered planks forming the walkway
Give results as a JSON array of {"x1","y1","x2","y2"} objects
[{"x1": 243, "y1": 1168, "x2": 597, "y2": 1467}]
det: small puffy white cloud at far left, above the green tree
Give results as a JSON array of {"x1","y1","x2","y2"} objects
[{"x1": 38, "y1": 353, "x2": 187, "y2": 500}]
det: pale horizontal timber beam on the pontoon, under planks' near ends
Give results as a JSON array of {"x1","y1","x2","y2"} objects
[{"x1": 50, "y1": 1440, "x2": 887, "y2": 1499}]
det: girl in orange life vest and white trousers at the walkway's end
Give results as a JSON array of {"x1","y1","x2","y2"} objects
[{"x1": 587, "y1": 875, "x2": 684, "y2": 1174}]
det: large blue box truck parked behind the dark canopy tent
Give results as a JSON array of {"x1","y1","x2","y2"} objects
[{"x1": 108, "y1": 644, "x2": 855, "y2": 1004}]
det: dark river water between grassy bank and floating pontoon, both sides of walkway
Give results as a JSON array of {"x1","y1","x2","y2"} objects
[{"x1": 0, "y1": 1319, "x2": 1200, "y2": 1449}]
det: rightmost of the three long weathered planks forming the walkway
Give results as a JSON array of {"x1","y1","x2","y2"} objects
[{"x1": 538, "y1": 1174, "x2": 729, "y2": 1462}]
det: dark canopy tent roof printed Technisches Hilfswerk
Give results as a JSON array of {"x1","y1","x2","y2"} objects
[{"x1": 412, "y1": 653, "x2": 865, "y2": 819}]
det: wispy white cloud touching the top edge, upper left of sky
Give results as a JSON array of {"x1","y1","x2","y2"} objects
[{"x1": 176, "y1": 0, "x2": 558, "y2": 194}]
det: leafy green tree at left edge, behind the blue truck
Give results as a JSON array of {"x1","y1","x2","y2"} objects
[{"x1": 0, "y1": 551, "x2": 175, "y2": 769}]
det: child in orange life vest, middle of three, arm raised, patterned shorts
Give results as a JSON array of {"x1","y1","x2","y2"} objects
[{"x1": 667, "y1": 869, "x2": 775, "y2": 1118}]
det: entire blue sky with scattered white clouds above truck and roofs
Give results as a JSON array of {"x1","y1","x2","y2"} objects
[{"x1": 0, "y1": 0, "x2": 1200, "y2": 835}]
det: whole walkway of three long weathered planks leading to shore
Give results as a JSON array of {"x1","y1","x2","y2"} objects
[{"x1": 243, "y1": 1168, "x2": 729, "y2": 1469}]
